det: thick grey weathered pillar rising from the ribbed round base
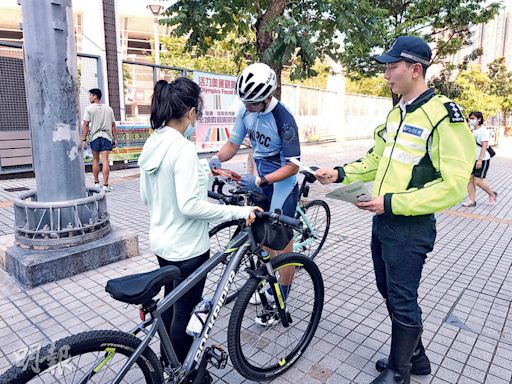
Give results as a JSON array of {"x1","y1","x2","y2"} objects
[{"x1": 20, "y1": 0, "x2": 86, "y2": 202}]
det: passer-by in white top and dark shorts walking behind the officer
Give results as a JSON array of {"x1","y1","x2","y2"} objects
[{"x1": 462, "y1": 111, "x2": 497, "y2": 207}]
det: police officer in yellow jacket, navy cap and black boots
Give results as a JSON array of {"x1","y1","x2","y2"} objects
[{"x1": 316, "y1": 36, "x2": 476, "y2": 384}]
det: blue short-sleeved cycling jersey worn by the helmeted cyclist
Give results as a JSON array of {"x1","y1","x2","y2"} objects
[{"x1": 229, "y1": 98, "x2": 300, "y2": 212}]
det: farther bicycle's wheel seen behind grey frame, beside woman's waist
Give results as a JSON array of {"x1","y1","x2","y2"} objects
[{"x1": 208, "y1": 220, "x2": 247, "y2": 304}]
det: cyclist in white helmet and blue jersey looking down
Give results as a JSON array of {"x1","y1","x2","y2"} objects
[{"x1": 209, "y1": 63, "x2": 300, "y2": 325}]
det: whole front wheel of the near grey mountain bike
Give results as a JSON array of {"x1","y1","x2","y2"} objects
[{"x1": 228, "y1": 253, "x2": 324, "y2": 381}]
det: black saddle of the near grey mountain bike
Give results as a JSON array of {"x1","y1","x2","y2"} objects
[{"x1": 105, "y1": 265, "x2": 181, "y2": 305}]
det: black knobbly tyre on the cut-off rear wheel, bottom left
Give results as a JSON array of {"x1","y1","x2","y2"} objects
[{"x1": 0, "y1": 331, "x2": 163, "y2": 384}]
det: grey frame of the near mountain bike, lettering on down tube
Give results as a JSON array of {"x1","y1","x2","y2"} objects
[{"x1": 107, "y1": 228, "x2": 257, "y2": 384}]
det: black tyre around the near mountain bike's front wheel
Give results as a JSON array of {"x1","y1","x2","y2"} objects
[{"x1": 228, "y1": 253, "x2": 324, "y2": 381}]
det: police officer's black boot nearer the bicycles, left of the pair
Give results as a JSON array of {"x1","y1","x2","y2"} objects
[{"x1": 371, "y1": 319, "x2": 422, "y2": 384}]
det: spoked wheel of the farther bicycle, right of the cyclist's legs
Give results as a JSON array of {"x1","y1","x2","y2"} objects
[{"x1": 293, "y1": 200, "x2": 331, "y2": 259}]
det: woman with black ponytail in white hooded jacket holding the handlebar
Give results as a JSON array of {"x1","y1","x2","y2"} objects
[{"x1": 138, "y1": 77, "x2": 261, "y2": 363}]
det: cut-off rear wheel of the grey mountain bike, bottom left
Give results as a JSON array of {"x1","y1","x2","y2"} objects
[{"x1": 0, "y1": 331, "x2": 163, "y2": 384}]
